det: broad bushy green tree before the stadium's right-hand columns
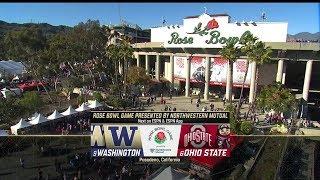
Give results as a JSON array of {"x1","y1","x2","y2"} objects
[{"x1": 257, "y1": 83, "x2": 296, "y2": 113}]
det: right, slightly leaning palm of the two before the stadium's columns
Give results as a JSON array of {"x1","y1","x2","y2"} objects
[{"x1": 236, "y1": 33, "x2": 258, "y2": 119}]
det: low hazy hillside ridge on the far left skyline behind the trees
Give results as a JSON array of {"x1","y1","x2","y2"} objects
[{"x1": 0, "y1": 20, "x2": 71, "y2": 36}]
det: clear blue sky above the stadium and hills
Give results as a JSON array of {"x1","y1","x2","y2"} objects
[{"x1": 0, "y1": 3, "x2": 320, "y2": 34}]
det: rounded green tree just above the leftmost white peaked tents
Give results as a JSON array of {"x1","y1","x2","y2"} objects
[{"x1": 17, "y1": 91, "x2": 43, "y2": 114}]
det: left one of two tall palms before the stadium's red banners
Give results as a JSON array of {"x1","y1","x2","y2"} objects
[{"x1": 219, "y1": 41, "x2": 240, "y2": 105}]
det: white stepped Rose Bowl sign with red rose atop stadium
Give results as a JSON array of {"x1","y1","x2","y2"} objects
[{"x1": 151, "y1": 14, "x2": 288, "y2": 48}]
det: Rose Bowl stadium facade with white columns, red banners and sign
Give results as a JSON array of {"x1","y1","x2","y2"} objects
[{"x1": 133, "y1": 13, "x2": 320, "y2": 102}]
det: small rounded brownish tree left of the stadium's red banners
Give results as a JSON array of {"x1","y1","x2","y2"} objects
[{"x1": 127, "y1": 66, "x2": 151, "y2": 85}]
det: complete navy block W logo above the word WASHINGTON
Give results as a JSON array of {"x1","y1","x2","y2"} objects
[{"x1": 108, "y1": 126, "x2": 138, "y2": 146}]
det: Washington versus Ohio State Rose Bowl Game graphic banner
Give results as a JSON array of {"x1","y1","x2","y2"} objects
[{"x1": 91, "y1": 111, "x2": 230, "y2": 160}]
